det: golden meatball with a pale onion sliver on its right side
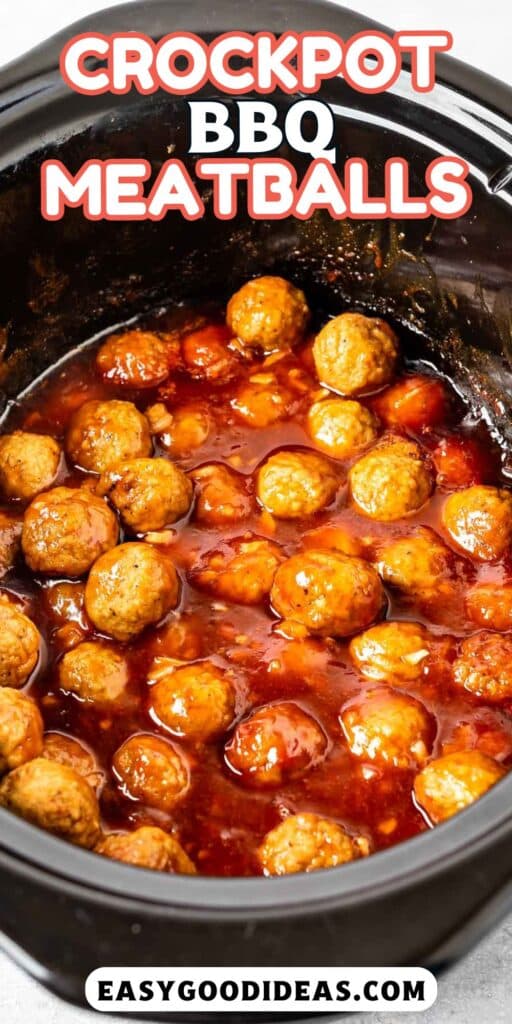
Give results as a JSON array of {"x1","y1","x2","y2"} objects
[{"x1": 350, "y1": 623, "x2": 430, "y2": 684}]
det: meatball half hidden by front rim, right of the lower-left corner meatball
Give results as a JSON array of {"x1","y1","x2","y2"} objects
[{"x1": 94, "y1": 825, "x2": 196, "y2": 874}]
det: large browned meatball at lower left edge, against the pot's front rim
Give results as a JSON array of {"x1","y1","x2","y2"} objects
[{"x1": 0, "y1": 758, "x2": 99, "y2": 848}]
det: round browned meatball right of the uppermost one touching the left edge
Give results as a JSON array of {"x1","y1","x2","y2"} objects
[{"x1": 66, "y1": 399, "x2": 152, "y2": 473}]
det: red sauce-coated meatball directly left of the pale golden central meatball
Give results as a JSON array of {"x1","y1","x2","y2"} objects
[{"x1": 191, "y1": 463, "x2": 252, "y2": 526}]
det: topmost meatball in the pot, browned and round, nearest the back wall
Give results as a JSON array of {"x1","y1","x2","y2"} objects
[{"x1": 226, "y1": 276, "x2": 309, "y2": 353}]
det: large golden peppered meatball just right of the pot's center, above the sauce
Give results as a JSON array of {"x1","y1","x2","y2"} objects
[{"x1": 349, "y1": 438, "x2": 433, "y2": 522}]
